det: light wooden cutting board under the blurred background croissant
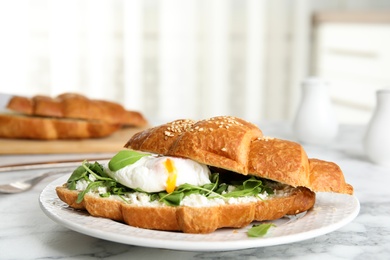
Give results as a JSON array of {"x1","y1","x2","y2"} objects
[{"x1": 0, "y1": 127, "x2": 147, "y2": 155}]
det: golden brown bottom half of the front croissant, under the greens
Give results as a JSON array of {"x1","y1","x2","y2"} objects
[{"x1": 56, "y1": 186, "x2": 315, "y2": 233}]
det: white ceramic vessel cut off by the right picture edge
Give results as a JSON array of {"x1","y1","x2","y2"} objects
[{"x1": 363, "y1": 89, "x2": 390, "y2": 167}]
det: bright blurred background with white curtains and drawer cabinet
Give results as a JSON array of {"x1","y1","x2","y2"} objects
[{"x1": 0, "y1": 0, "x2": 390, "y2": 124}]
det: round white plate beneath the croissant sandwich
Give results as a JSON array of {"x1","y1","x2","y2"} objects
[{"x1": 39, "y1": 176, "x2": 360, "y2": 251}]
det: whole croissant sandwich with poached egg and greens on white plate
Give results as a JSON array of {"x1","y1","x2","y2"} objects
[{"x1": 56, "y1": 117, "x2": 353, "y2": 233}]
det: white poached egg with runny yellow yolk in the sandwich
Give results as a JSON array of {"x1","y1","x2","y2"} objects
[{"x1": 105, "y1": 155, "x2": 210, "y2": 193}]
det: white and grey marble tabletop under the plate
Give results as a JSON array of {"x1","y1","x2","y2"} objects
[{"x1": 0, "y1": 123, "x2": 390, "y2": 260}]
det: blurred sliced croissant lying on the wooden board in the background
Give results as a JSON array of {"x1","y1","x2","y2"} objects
[{"x1": 0, "y1": 93, "x2": 148, "y2": 140}]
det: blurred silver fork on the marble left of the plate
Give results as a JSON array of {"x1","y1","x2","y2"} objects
[{"x1": 0, "y1": 169, "x2": 69, "y2": 194}]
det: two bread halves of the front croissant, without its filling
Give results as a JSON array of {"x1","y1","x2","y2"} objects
[{"x1": 56, "y1": 116, "x2": 353, "y2": 233}]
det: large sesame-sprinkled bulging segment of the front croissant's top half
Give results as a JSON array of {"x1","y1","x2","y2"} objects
[{"x1": 167, "y1": 117, "x2": 263, "y2": 174}]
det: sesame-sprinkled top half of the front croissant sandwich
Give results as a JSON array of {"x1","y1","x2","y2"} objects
[{"x1": 125, "y1": 117, "x2": 353, "y2": 194}]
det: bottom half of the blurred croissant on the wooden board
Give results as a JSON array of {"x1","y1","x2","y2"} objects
[{"x1": 0, "y1": 114, "x2": 120, "y2": 140}]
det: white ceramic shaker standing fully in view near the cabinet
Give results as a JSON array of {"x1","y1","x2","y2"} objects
[{"x1": 293, "y1": 78, "x2": 338, "y2": 145}]
